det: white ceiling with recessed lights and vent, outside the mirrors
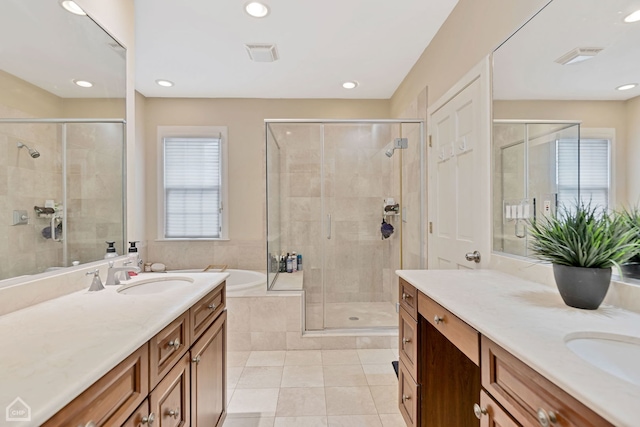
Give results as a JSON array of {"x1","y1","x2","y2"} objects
[{"x1": 135, "y1": 0, "x2": 457, "y2": 99}]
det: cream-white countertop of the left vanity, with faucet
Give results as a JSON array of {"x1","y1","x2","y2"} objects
[{"x1": 0, "y1": 273, "x2": 229, "y2": 426}]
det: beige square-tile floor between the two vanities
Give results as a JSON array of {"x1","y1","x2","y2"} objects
[{"x1": 223, "y1": 349, "x2": 406, "y2": 427}]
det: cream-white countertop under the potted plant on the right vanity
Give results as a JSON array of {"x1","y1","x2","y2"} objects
[{"x1": 396, "y1": 270, "x2": 640, "y2": 427}]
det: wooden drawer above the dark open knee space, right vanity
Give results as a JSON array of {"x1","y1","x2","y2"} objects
[{"x1": 418, "y1": 292, "x2": 480, "y2": 366}]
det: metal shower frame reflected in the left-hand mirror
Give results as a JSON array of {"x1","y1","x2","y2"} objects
[{"x1": 0, "y1": 118, "x2": 127, "y2": 267}]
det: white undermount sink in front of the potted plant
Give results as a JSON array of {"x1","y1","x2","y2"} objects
[{"x1": 565, "y1": 332, "x2": 640, "y2": 386}]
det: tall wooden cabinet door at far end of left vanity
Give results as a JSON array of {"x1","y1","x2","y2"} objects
[{"x1": 191, "y1": 311, "x2": 227, "y2": 427}]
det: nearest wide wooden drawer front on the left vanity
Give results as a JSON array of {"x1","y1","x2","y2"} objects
[{"x1": 44, "y1": 343, "x2": 149, "y2": 427}]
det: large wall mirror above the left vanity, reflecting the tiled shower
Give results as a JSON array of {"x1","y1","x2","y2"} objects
[{"x1": 0, "y1": 0, "x2": 126, "y2": 286}]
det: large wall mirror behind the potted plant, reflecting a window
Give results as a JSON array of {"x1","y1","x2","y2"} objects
[{"x1": 492, "y1": 0, "x2": 640, "y2": 272}]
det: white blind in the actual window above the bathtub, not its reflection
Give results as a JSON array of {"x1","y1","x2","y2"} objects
[{"x1": 163, "y1": 137, "x2": 221, "y2": 238}]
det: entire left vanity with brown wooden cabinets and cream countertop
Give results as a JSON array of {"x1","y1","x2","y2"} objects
[{"x1": 0, "y1": 273, "x2": 228, "y2": 427}]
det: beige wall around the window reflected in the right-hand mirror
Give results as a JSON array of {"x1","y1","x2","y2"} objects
[{"x1": 493, "y1": 101, "x2": 640, "y2": 204}]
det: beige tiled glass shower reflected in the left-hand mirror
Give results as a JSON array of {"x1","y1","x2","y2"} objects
[{"x1": 0, "y1": 118, "x2": 125, "y2": 280}]
